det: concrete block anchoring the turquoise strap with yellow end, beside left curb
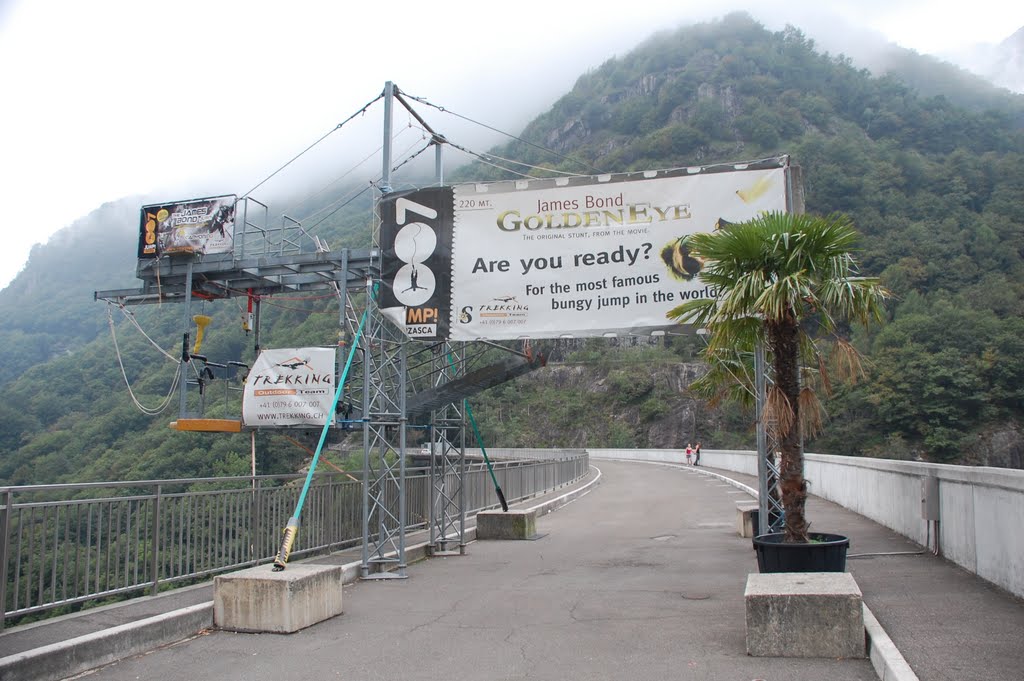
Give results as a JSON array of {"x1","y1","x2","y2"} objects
[{"x1": 213, "y1": 563, "x2": 344, "y2": 634}]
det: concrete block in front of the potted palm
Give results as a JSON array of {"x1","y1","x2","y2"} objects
[{"x1": 743, "y1": 572, "x2": 864, "y2": 657}]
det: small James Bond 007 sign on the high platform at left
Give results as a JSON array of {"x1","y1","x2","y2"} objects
[{"x1": 138, "y1": 195, "x2": 238, "y2": 258}]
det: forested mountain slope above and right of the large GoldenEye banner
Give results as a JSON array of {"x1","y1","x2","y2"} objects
[{"x1": 475, "y1": 14, "x2": 1024, "y2": 467}]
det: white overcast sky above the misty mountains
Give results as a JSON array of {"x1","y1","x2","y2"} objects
[{"x1": 0, "y1": 0, "x2": 1024, "y2": 287}]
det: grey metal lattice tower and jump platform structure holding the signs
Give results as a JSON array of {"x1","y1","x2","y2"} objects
[{"x1": 94, "y1": 82, "x2": 536, "y2": 579}]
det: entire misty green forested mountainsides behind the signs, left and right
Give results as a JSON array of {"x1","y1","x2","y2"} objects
[{"x1": 0, "y1": 14, "x2": 1024, "y2": 483}]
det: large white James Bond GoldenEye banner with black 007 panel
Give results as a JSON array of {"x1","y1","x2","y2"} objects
[{"x1": 381, "y1": 157, "x2": 788, "y2": 341}]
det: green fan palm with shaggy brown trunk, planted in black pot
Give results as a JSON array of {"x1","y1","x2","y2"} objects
[{"x1": 668, "y1": 213, "x2": 889, "y2": 542}]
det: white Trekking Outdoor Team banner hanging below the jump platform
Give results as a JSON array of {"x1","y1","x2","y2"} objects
[{"x1": 242, "y1": 347, "x2": 335, "y2": 428}]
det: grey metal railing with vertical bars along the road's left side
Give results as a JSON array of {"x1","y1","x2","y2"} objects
[{"x1": 0, "y1": 451, "x2": 589, "y2": 628}]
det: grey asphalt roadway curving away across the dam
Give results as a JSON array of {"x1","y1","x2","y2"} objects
[{"x1": 80, "y1": 462, "x2": 878, "y2": 681}]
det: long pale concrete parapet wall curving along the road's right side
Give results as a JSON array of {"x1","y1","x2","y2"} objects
[{"x1": 590, "y1": 450, "x2": 1024, "y2": 597}]
